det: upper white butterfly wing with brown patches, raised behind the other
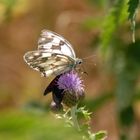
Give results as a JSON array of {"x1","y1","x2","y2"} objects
[{"x1": 38, "y1": 30, "x2": 76, "y2": 58}]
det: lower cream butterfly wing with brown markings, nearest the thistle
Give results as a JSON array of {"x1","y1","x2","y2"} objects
[{"x1": 24, "y1": 50, "x2": 75, "y2": 76}]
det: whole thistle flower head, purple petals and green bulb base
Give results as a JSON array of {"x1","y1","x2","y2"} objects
[{"x1": 57, "y1": 71, "x2": 84, "y2": 107}]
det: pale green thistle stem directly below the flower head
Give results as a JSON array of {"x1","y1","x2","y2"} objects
[{"x1": 71, "y1": 105, "x2": 80, "y2": 131}]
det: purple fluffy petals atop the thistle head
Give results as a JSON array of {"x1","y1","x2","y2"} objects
[{"x1": 57, "y1": 71, "x2": 84, "y2": 93}]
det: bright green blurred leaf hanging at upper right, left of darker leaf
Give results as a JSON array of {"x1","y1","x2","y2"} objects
[{"x1": 101, "y1": 0, "x2": 128, "y2": 52}]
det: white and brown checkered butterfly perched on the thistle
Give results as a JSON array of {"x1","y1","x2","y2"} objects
[{"x1": 24, "y1": 30, "x2": 82, "y2": 77}]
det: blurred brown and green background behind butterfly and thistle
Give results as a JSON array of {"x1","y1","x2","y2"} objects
[{"x1": 0, "y1": 0, "x2": 140, "y2": 140}]
